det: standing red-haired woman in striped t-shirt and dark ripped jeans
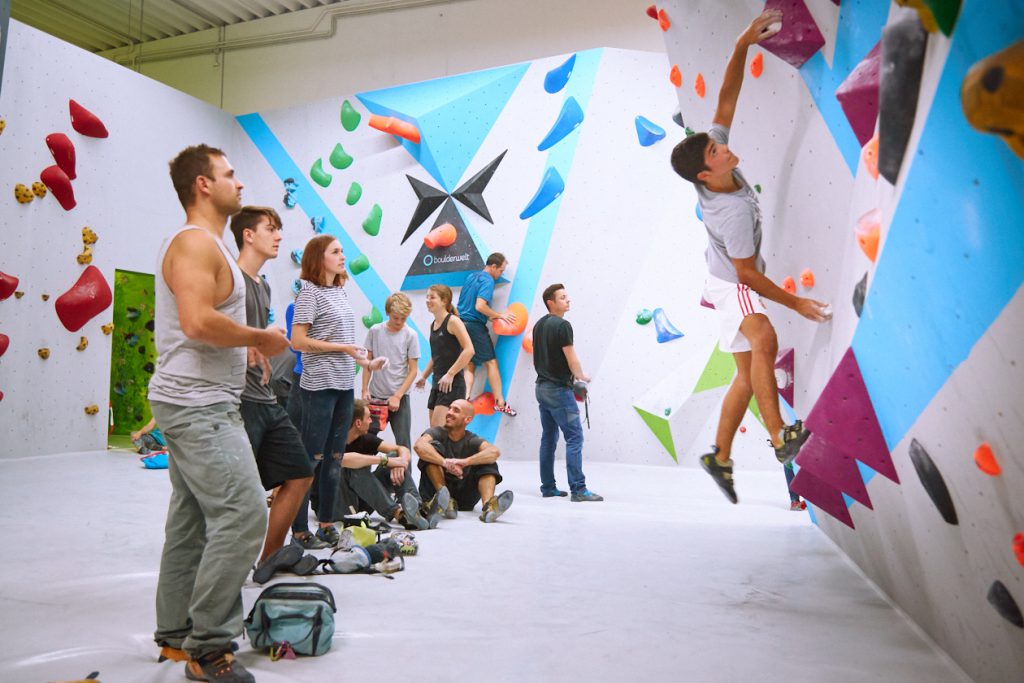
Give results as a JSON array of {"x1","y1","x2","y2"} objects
[{"x1": 292, "y1": 234, "x2": 385, "y2": 549}]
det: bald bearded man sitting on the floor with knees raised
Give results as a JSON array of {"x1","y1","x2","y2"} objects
[{"x1": 413, "y1": 399, "x2": 513, "y2": 522}]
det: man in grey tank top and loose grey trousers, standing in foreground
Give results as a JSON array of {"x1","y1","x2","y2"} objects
[{"x1": 150, "y1": 144, "x2": 288, "y2": 683}]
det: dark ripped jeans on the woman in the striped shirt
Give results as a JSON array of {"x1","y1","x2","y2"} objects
[{"x1": 292, "y1": 389, "x2": 355, "y2": 532}]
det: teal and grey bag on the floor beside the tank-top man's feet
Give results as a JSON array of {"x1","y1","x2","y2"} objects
[{"x1": 245, "y1": 583, "x2": 338, "y2": 655}]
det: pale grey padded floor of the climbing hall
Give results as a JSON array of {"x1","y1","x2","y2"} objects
[{"x1": 0, "y1": 452, "x2": 967, "y2": 683}]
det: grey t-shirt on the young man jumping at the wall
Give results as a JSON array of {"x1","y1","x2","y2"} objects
[{"x1": 693, "y1": 124, "x2": 765, "y2": 283}]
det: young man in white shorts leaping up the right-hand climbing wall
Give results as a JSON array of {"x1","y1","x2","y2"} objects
[{"x1": 672, "y1": 9, "x2": 831, "y2": 503}]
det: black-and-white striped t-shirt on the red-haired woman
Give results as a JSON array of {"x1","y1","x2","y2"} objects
[{"x1": 292, "y1": 281, "x2": 355, "y2": 391}]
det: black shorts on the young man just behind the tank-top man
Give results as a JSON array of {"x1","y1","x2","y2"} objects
[{"x1": 241, "y1": 400, "x2": 313, "y2": 490}]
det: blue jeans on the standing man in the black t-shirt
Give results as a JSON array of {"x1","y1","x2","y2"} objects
[{"x1": 536, "y1": 382, "x2": 587, "y2": 494}]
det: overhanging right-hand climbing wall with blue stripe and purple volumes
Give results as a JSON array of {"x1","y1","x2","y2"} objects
[{"x1": 655, "y1": 0, "x2": 1024, "y2": 681}]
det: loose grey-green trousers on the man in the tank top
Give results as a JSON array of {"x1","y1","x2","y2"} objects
[{"x1": 151, "y1": 401, "x2": 267, "y2": 656}]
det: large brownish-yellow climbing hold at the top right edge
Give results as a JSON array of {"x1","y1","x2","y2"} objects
[{"x1": 961, "y1": 40, "x2": 1024, "y2": 159}]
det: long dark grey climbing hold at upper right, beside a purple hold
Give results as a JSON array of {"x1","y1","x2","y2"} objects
[{"x1": 877, "y1": 16, "x2": 928, "y2": 185}]
